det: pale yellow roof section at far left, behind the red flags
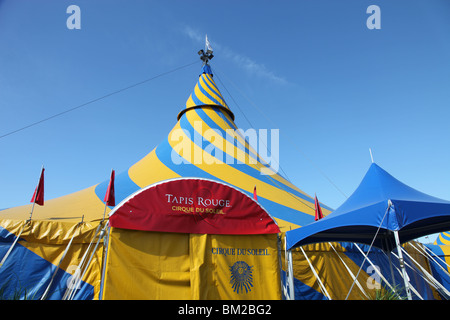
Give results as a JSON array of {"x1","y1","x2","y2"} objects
[{"x1": 1, "y1": 186, "x2": 105, "y2": 222}]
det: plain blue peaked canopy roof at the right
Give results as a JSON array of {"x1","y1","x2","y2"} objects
[{"x1": 286, "y1": 163, "x2": 450, "y2": 251}]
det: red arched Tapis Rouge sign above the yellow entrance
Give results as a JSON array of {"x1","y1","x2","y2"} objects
[{"x1": 109, "y1": 178, "x2": 280, "y2": 234}]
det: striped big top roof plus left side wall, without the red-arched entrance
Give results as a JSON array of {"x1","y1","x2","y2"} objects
[{"x1": 0, "y1": 64, "x2": 329, "y2": 299}]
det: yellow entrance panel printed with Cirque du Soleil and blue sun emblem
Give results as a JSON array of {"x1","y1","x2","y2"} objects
[{"x1": 190, "y1": 234, "x2": 281, "y2": 300}]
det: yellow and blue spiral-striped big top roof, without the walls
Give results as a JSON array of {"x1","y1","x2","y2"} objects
[{"x1": 0, "y1": 65, "x2": 329, "y2": 231}]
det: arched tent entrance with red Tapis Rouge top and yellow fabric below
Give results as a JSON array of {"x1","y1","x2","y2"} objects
[{"x1": 102, "y1": 178, "x2": 281, "y2": 300}]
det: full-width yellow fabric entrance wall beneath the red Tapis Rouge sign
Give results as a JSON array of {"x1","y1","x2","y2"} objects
[{"x1": 103, "y1": 228, "x2": 281, "y2": 300}]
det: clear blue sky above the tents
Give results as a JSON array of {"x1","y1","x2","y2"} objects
[{"x1": 0, "y1": 0, "x2": 450, "y2": 232}]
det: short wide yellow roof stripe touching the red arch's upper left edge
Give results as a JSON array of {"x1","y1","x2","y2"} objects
[{"x1": 128, "y1": 149, "x2": 180, "y2": 188}]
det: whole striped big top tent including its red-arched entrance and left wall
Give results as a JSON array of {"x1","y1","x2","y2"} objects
[{"x1": 0, "y1": 49, "x2": 329, "y2": 299}]
